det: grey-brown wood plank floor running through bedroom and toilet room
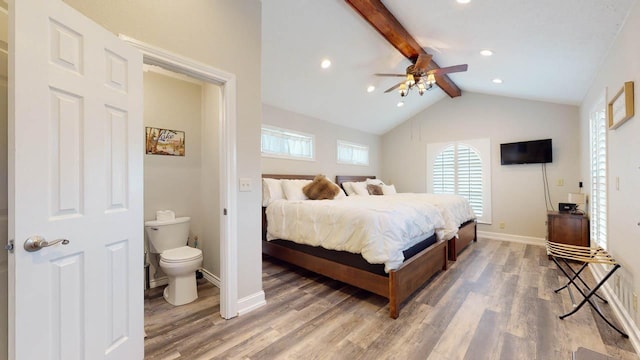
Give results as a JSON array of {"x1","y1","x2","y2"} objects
[{"x1": 145, "y1": 240, "x2": 637, "y2": 360}]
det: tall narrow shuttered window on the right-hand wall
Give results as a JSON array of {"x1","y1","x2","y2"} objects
[{"x1": 589, "y1": 99, "x2": 607, "y2": 249}]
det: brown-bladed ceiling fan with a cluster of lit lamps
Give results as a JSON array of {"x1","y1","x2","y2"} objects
[{"x1": 375, "y1": 53, "x2": 468, "y2": 97}]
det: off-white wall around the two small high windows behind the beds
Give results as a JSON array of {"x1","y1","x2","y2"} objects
[{"x1": 262, "y1": 104, "x2": 380, "y2": 180}]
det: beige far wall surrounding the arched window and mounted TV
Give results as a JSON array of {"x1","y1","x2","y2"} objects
[{"x1": 382, "y1": 92, "x2": 581, "y2": 239}]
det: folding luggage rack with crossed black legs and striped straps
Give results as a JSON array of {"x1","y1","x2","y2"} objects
[{"x1": 547, "y1": 241, "x2": 629, "y2": 338}]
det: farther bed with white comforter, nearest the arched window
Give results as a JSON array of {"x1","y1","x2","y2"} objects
[{"x1": 336, "y1": 175, "x2": 478, "y2": 261}]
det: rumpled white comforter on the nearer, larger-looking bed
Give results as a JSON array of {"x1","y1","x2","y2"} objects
[{"x1": 266, "y1": 196, "x2": 444, "y2": 272}]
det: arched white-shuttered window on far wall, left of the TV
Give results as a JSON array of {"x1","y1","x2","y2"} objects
[{"x1": 427, "y1": 139, "x2": 491, "y2": 224}]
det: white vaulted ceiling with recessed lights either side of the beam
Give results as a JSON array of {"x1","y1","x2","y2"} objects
[{"x1": 262, "y1": 0, "x2": 637, "y2": 134}]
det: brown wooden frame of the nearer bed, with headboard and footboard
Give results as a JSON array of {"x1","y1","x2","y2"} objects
[{"x1": 262, "y1": 175, "x2": 447, "y2": 319}]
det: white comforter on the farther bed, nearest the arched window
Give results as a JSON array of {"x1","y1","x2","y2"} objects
[{"x1": 384, "y1": 193, "x2": 476, "y2": 240}]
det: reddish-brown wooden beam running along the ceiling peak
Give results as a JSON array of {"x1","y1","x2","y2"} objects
[{"x1": 345, "y1": 0, "x2": 462, "y2": 98}]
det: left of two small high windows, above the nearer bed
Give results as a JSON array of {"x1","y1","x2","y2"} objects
[{"x1": 261, "y1": 125, "x2": 315, "y2": 160}]
